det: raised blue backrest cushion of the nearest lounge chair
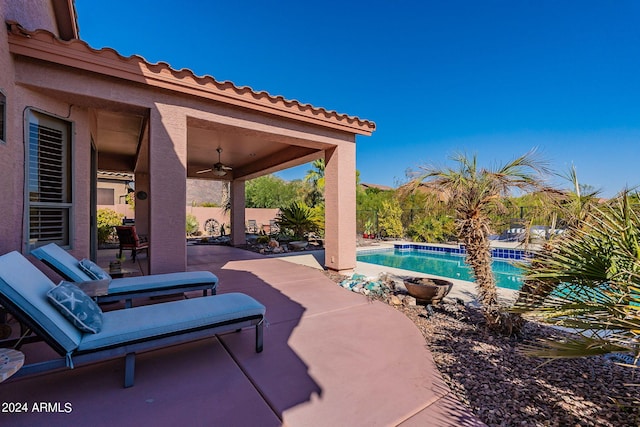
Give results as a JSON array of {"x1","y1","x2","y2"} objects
[{"x1": 0, "y1": 251, "x2": 82, "y2": 352}]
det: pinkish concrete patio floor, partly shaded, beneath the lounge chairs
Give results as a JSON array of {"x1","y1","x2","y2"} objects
[{"x1": 0, "y1": 246, "x2": 483, "y2": 426}]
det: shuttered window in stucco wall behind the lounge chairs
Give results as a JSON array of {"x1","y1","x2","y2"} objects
[{"x1": 26, "y1": 111, "x2": 72, "y2": 249}]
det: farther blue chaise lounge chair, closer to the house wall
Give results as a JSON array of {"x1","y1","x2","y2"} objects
[{"x1": 31, "y1": 243, "x2": 218, "y2": 308}]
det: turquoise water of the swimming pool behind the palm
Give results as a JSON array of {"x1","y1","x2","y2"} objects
[{"x1": 358, "y1": 249, "x2": 522, "y2": 290}]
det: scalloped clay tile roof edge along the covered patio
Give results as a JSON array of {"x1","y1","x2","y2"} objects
[{"x1": 6, "y1": 21, "x2": 376, "y2": 135}]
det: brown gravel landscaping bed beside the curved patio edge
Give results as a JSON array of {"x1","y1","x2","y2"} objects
[{"x1": 330, "y1": 275, "x2": 640, "y2": 427}]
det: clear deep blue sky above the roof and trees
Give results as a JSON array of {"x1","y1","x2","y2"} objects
[{"x1": 76, "y1": 0, "x2": 640, "y2": 196}]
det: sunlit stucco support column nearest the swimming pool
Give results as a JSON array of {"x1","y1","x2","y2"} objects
[{"x1": 324, "y1": 142, "x2": 356, "y2": 273}]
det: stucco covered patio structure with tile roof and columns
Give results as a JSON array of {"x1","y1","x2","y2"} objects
[{"x1": 5, "y1": 21, "x2": 375, "y2": 273}]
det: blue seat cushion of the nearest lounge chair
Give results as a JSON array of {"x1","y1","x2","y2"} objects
[{"x1": 78, "y1": 293, "x2": 265, "y2": 352}]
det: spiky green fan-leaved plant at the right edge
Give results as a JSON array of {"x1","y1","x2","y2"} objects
[{"x1": 513, "y1": 192, "x2": 640, "y2": 361}]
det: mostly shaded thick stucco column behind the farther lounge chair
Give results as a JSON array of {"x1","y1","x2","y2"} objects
[{"x1": 147, "y1": 104, "x2": 187, "y2": 274}]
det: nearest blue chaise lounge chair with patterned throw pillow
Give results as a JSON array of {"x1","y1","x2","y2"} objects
[{"x1": 0, "y1": 251, "x2": 265, "y2": 387}]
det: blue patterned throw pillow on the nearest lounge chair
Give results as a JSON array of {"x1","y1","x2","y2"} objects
[{"x1": 47, "y1": 280, "x2": 102, "y2": 334}]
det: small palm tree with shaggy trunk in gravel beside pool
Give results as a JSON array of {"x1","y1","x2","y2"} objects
[{"x1": 412, "y1": 151, "x2": 548, "y2": 333}]
